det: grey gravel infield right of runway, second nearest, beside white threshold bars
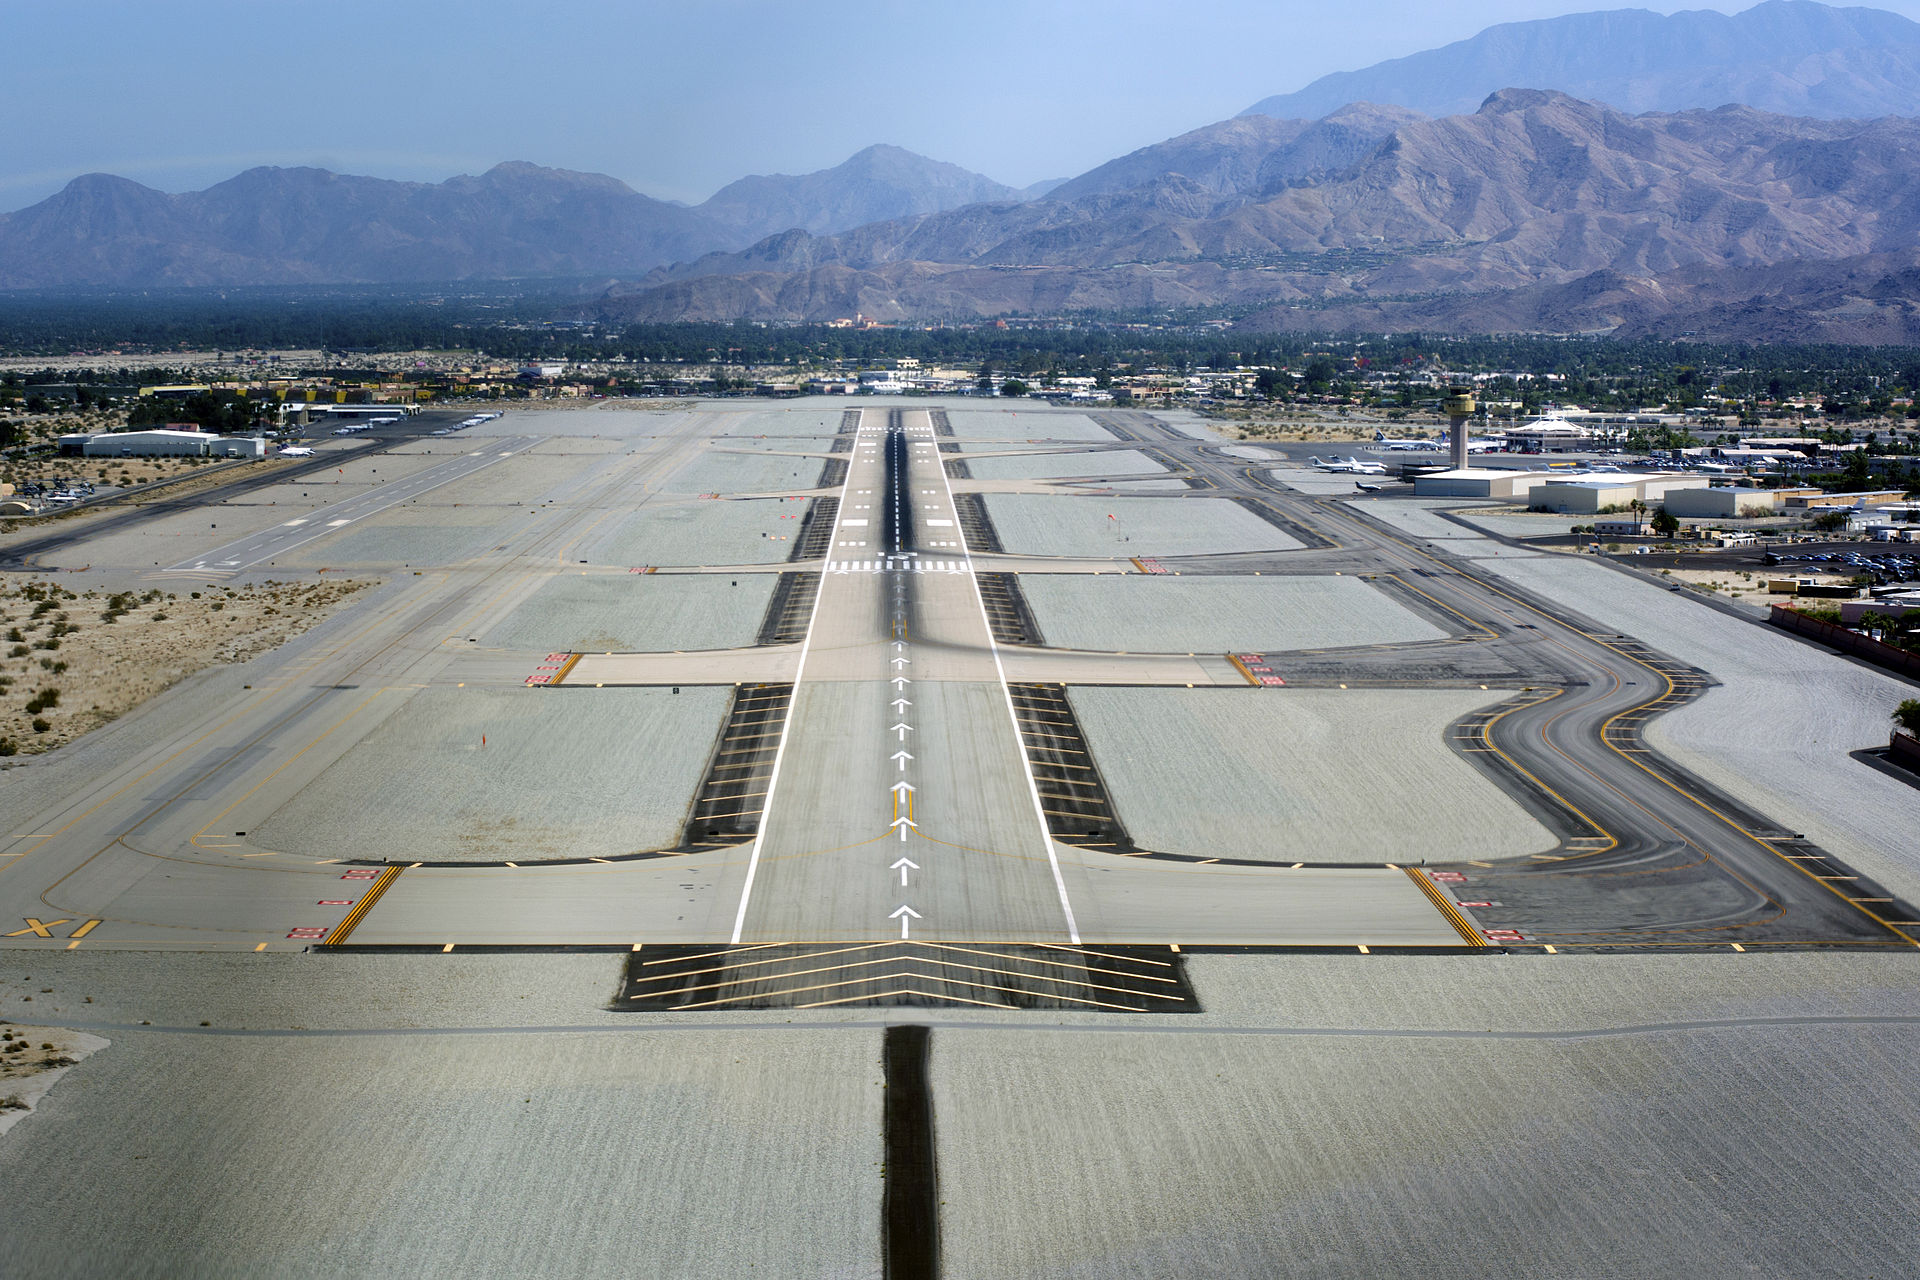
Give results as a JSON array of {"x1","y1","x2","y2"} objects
[{"x1": 1020, "y1": 574, "x2": 1446, "y2": 652}]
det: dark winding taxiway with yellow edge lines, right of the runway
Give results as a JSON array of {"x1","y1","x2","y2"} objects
[{"x1": 1125, "y1": 415, "x2": 1920, "y2": 948}]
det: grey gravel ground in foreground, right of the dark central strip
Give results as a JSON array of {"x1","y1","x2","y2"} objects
[{"x1": 933, "y1": 1013, "x2": 1920, "y2": 1278}]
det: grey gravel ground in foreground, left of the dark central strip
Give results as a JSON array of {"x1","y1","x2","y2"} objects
[{"x1": 0, "y1": 1031, "x2": 883, "y2": 1280}]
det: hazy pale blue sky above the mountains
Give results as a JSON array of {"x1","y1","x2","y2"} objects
[{"x1": 0, "y1": 0, "x2": 1920, "y2": 209}]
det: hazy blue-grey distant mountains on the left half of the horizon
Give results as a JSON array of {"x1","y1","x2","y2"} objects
[{"x1": 0, "y1": 146, "x2": 1023, "y2": 290}]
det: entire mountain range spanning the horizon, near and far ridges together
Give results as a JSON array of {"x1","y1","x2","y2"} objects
[{"x1": 11, "y1": 0, "x2": 1920, "y2": 342}]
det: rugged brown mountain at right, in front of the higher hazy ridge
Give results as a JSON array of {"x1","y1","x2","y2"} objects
[{"x1": 601, "y1": 90, "x2": 1920, "y2": 339}]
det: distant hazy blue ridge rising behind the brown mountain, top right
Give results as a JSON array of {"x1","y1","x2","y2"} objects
[{"x1": 1246, "y1": 0, "x2": 1920, "y2": 119}]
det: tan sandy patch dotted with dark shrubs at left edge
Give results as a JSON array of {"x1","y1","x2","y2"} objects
[{"x1": 0, "y1": 578, "x2": 369, "y2": 754}]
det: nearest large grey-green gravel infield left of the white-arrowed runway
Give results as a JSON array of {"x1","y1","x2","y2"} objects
[{"x1": 248, "y1": 687, "x2": 732, "y2": 862}]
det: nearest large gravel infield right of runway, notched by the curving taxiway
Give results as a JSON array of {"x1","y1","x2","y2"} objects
[{"x1": 1071, "y1": 689, "x2": 1555, "y2": 862}]
